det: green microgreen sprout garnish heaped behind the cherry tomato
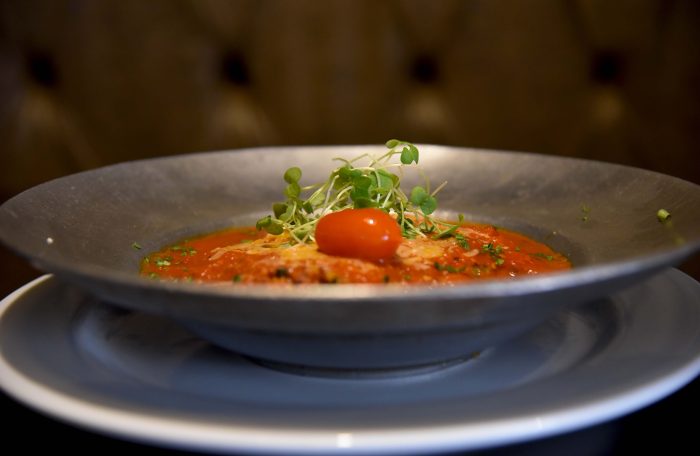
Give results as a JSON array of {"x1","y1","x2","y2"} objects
[{"x1": 255, "y1": 139, "x2": 463, "y2": 243}]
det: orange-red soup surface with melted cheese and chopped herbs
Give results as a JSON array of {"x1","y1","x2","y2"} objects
[{"x1": 141, "y1": 223, "x2": 571, "y2": 284}]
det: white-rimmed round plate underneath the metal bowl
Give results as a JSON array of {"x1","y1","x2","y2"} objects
[{"x1": 0, "y1": 270, "x2": 700, "y2": 454}]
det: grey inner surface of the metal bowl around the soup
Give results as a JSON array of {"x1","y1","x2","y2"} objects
[{"x1": 1, "y1": 146, "x2": 700, "y2": 274}]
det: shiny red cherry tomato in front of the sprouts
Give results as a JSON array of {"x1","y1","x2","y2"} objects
[{"x1": 316, "y1": 208, "x2": 402, "y2": 262}]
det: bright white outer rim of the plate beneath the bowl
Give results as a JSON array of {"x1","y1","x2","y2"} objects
[{"x1": 0, "y1": 269, "x2": 700, "y2": 454}]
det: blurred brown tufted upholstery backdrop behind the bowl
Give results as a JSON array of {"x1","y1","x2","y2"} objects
[{"x1": 0, "y1": 0, "x2": 700, "y2": 295}]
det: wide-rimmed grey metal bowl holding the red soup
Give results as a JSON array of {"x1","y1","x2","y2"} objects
[{"x1": 0, "y1": 145, "x2": 700, "y2": 371}]
